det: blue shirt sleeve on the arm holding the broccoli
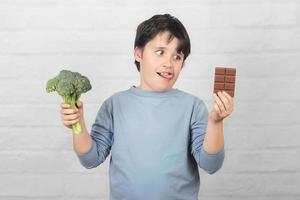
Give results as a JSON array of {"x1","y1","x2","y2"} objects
[{"x1": 77, "y1": 100, "x2": 113, "y2": 169}]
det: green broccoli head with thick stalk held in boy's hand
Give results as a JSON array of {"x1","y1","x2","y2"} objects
[{"x1": 46, "y1": 70, "x2": 92, "y2": 134}]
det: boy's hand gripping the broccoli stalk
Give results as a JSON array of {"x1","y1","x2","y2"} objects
[{"x1": 60, "y1": 101, "x2": 84, "y2": 128}]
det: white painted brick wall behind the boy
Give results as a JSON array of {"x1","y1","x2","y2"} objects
[{"x1": 0, "y1": 0, "x2": 300, "y2": 200}]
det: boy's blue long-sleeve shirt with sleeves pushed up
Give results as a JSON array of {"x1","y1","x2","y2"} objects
[{"x1": 77, "y1": 86, "x2": 224, "y2": 200}]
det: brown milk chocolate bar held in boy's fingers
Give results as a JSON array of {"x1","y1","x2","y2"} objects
[{"x1": 214, "y1": 67, "x2": 236, "y2": 97}]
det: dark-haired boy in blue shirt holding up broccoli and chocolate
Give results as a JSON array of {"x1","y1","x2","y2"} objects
[{"x1": 61, "y1": 14, "x2": 233, "y2": 200}]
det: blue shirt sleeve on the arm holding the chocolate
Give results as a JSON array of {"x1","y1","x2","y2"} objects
[{"x1": 190, "y1": 99, "x2": 225, "y2": 174}]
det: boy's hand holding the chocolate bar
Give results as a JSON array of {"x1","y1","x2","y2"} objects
[{"x1": 210, "y1": 91, "x2": 233, "y2": 122}]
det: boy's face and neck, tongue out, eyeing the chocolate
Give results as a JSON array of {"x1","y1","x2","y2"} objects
[{"x1": 134, "y1": 32, "x2": 184, "y2": 92}]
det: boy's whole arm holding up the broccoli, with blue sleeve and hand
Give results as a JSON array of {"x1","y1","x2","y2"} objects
[{"x1": 62, "y1": 101, "x2": 113, "y2": 168}]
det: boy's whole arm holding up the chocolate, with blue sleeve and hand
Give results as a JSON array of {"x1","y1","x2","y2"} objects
[{"x1": 191, "y1": 91, "x2": 233, "y2": 174}]
